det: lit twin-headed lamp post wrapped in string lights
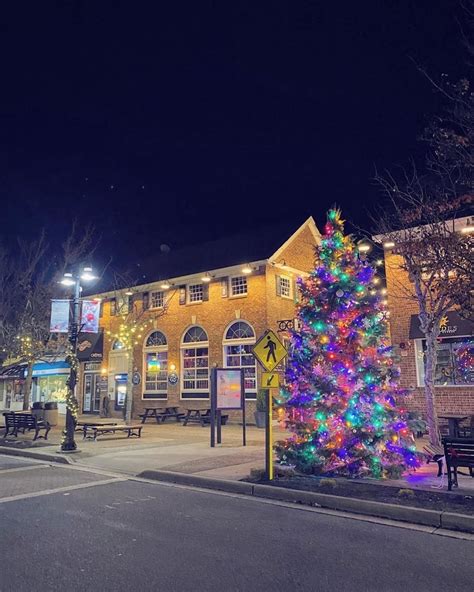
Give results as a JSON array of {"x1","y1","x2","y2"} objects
[{"x1": 60, "y1": 267, "x2": 97, "y2": 452}]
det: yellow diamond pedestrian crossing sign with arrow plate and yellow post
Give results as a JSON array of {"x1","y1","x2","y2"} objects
[{"x1": 252, "y1": 331, "x2": 288, "y2": 481}]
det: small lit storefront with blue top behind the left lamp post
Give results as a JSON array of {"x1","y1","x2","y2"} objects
[{"x1": 31, "y1": 360, "x2": 70, "y2": 414}]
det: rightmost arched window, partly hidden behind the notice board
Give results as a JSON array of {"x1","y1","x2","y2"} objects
[{"x1": 223, "y1": 321, "x2": 257, "y2": 399}]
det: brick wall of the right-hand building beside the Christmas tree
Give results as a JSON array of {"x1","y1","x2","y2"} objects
[{"x1": 385, "y1": 250, "x2": 474, "y2": 415}]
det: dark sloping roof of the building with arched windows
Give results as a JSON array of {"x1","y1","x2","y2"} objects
[{"x1": 89, "y1": 217, "x2": 319, "y2": 294}]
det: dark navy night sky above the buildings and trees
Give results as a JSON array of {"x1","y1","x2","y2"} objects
[{"x1": 0, "y1": 0, "x2": 462, "y2": 265}]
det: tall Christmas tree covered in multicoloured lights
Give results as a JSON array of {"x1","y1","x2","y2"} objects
[{"x1": 277, "y1": 210, "x2": 418, "y2": 477}]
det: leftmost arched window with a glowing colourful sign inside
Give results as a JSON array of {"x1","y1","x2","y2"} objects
[{"x1": 143, "y1": 331, "x2": 168, "y2": 399}]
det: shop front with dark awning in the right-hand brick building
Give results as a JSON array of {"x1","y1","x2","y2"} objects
[{"x1": 409, "y1": 312, "x2": 474, "y2": 387}]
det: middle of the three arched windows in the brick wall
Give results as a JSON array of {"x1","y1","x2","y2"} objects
[{"x1": 181, "y1": 325, "x2": 209, "y2": 399}]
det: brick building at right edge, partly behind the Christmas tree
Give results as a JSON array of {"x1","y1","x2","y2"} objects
[{"x1": 384, "y1": 234, "x2": 474, "y2": 416}]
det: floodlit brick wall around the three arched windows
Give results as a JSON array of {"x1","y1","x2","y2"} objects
[{"x1": 79, "y1": 222, "x2": 314, "y2": 422}]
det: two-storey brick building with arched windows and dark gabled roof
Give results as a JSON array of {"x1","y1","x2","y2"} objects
[{"x1": 78, "y1": 218, "x2": 320, "y2": 421}]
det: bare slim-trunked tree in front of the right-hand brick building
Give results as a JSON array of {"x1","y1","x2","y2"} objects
[{"x1": 377, "y1": 185, "x2": 474, "y2": 445}]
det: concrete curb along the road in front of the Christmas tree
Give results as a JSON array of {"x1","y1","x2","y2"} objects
[{"x1": 137, "y1": 470, "x2": 474, "y2": 534}]
